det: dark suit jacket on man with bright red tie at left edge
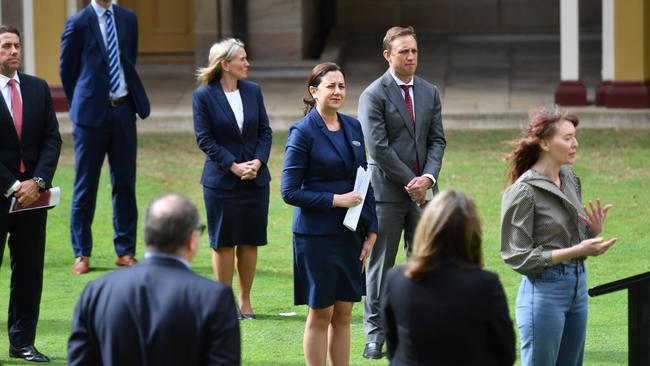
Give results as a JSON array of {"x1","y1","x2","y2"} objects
[{"x1": 0, "y1": 72, "x2": 61, "y2": 213}]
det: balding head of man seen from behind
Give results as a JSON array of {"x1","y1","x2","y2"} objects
[{"x1": 144, "y1": 194, "x2": 200, "y2": 260}]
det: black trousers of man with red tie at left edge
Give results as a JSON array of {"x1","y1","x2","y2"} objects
[{"x1": 0, "y1": 207, "x2": 47, "y2": 347}]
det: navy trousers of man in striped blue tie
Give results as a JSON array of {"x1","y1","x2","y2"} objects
[{"x1": 70, "y1": 101, "x2": 138, "y2": 257}]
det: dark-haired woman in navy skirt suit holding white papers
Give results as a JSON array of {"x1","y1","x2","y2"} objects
[{"x1": 282, "y1": 63, "x2": 377, "y2": 365}]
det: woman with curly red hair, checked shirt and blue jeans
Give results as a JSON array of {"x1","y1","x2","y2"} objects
[{"x1": 501, "y1": 106, "x2": 616, "y2": 366}]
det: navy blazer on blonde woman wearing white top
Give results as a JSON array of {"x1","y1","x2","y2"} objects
[{"x1": 192, "y1": 76, "x2": 272, "y2": 190}]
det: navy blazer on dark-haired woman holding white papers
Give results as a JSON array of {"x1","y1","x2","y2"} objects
[{"x1": 282, "y1": 108, "x2": 377, "y2": 235}]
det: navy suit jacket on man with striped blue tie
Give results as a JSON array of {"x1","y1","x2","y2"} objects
[{"x1": 60, "y1": 4, "x2": 150, "y2": 127}]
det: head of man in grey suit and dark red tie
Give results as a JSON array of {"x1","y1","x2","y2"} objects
[{"x1": 383, "y1": 27, "x2": 418, "y2": 82}]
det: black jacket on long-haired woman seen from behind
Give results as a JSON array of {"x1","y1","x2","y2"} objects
[{"x1": 381, "y1": 263, "x2": 515, "y2": 366}]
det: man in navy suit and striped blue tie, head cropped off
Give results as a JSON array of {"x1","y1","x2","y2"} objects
[{"x1": 60, "y1": 0, "x2": 149, "y2": 274}]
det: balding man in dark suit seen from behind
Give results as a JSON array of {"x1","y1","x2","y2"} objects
[{"x1": 68, "y1": 194, "x2": 241, "y2": 366}]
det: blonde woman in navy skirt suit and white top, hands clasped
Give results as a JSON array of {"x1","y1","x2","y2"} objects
[{"x1": 192, "y1": 39, "x2": 271, "y2": 319}]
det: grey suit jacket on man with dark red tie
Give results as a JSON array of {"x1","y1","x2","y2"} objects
[{"x1": 358, "y1": 71, "x2": 446, "y2": 202}]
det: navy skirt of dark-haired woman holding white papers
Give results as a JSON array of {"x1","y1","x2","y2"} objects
[{"x1": 293, "y1": 229, "x2": 366, "y2": 309}]
